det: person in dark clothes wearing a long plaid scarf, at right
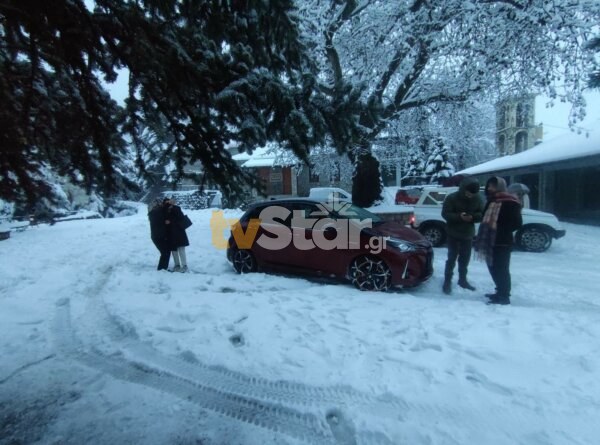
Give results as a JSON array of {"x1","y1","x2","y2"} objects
[{"x1": 475, "y1": 176, "x2": 523, "y2": 304}]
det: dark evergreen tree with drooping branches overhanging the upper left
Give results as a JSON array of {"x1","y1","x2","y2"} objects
[{"x1": 0, "y1": 0, "x2": 332, "y2": 207}]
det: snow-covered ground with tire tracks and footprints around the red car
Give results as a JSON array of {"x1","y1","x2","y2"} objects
[{"x1": 0, "y1": 208, "x2": 600, "y2": 445}]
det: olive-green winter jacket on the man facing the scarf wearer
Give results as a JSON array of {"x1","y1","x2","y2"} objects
[{"x1": 442, "y1": 178, "x2": 483, "y2": 240}]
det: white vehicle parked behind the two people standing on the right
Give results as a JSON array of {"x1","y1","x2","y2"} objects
[{"x1": 412, "y1": 187, "x2": 566, "y2": 252}]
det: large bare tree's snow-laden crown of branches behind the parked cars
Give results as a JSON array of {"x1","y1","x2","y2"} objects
[{"x1": 297, "y1": 0, "x2": 600, "y2": 205}]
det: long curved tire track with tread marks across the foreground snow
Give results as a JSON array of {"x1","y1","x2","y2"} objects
[{"x1": 65, "y1": 266, "x2": 544, "y2": 445}]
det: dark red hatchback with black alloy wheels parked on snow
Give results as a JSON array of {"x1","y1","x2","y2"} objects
[{"x1": 227, "y1": 198, "x2": 433, "y2": 291}]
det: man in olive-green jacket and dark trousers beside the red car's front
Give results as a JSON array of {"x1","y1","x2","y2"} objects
[{"x1": 442, "y1": 177, "x2": 483, "y2": 294}]
